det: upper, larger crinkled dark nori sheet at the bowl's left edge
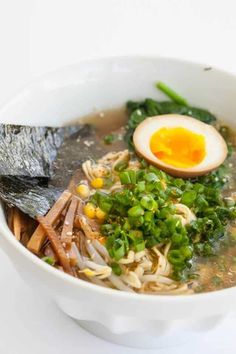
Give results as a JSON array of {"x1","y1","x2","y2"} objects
[{"x1": 0, "y1": 124, "x2": 83, "y2": 177}]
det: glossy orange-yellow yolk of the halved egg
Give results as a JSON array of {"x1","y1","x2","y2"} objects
[{"x1": 150, "y1": 127, "x2": 206, "y2": 168}]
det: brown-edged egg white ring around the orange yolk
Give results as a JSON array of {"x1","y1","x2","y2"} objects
[{"x1": 133, "y1": 114, "x2": 228, "y2": 178}]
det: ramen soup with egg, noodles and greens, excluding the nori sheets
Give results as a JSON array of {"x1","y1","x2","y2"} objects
[{"x1": 7, "y1": 83, "x2": 236, "y2": 295}]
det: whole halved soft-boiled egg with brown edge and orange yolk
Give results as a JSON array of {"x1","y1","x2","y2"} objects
[{"x1": 133, "y1": 114, "x2": 228, "y2": 178}]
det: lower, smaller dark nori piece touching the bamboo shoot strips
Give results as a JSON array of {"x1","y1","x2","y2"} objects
[{"x1": 0, "y1": 176, "x2": 62, "y2": 218}]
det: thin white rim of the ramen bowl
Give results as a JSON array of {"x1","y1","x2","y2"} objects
[{"x1": 0, "y1": 54, "x2": 236, "y2": 304}]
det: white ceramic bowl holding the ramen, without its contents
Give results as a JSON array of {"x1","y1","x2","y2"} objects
[{"x1": 0, "y1": 57, "x2": 236, "y2": 347}]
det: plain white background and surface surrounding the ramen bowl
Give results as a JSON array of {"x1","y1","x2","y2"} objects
[{"x1": 0, "y1": 0, "x2": 236, "y2": 354}]
